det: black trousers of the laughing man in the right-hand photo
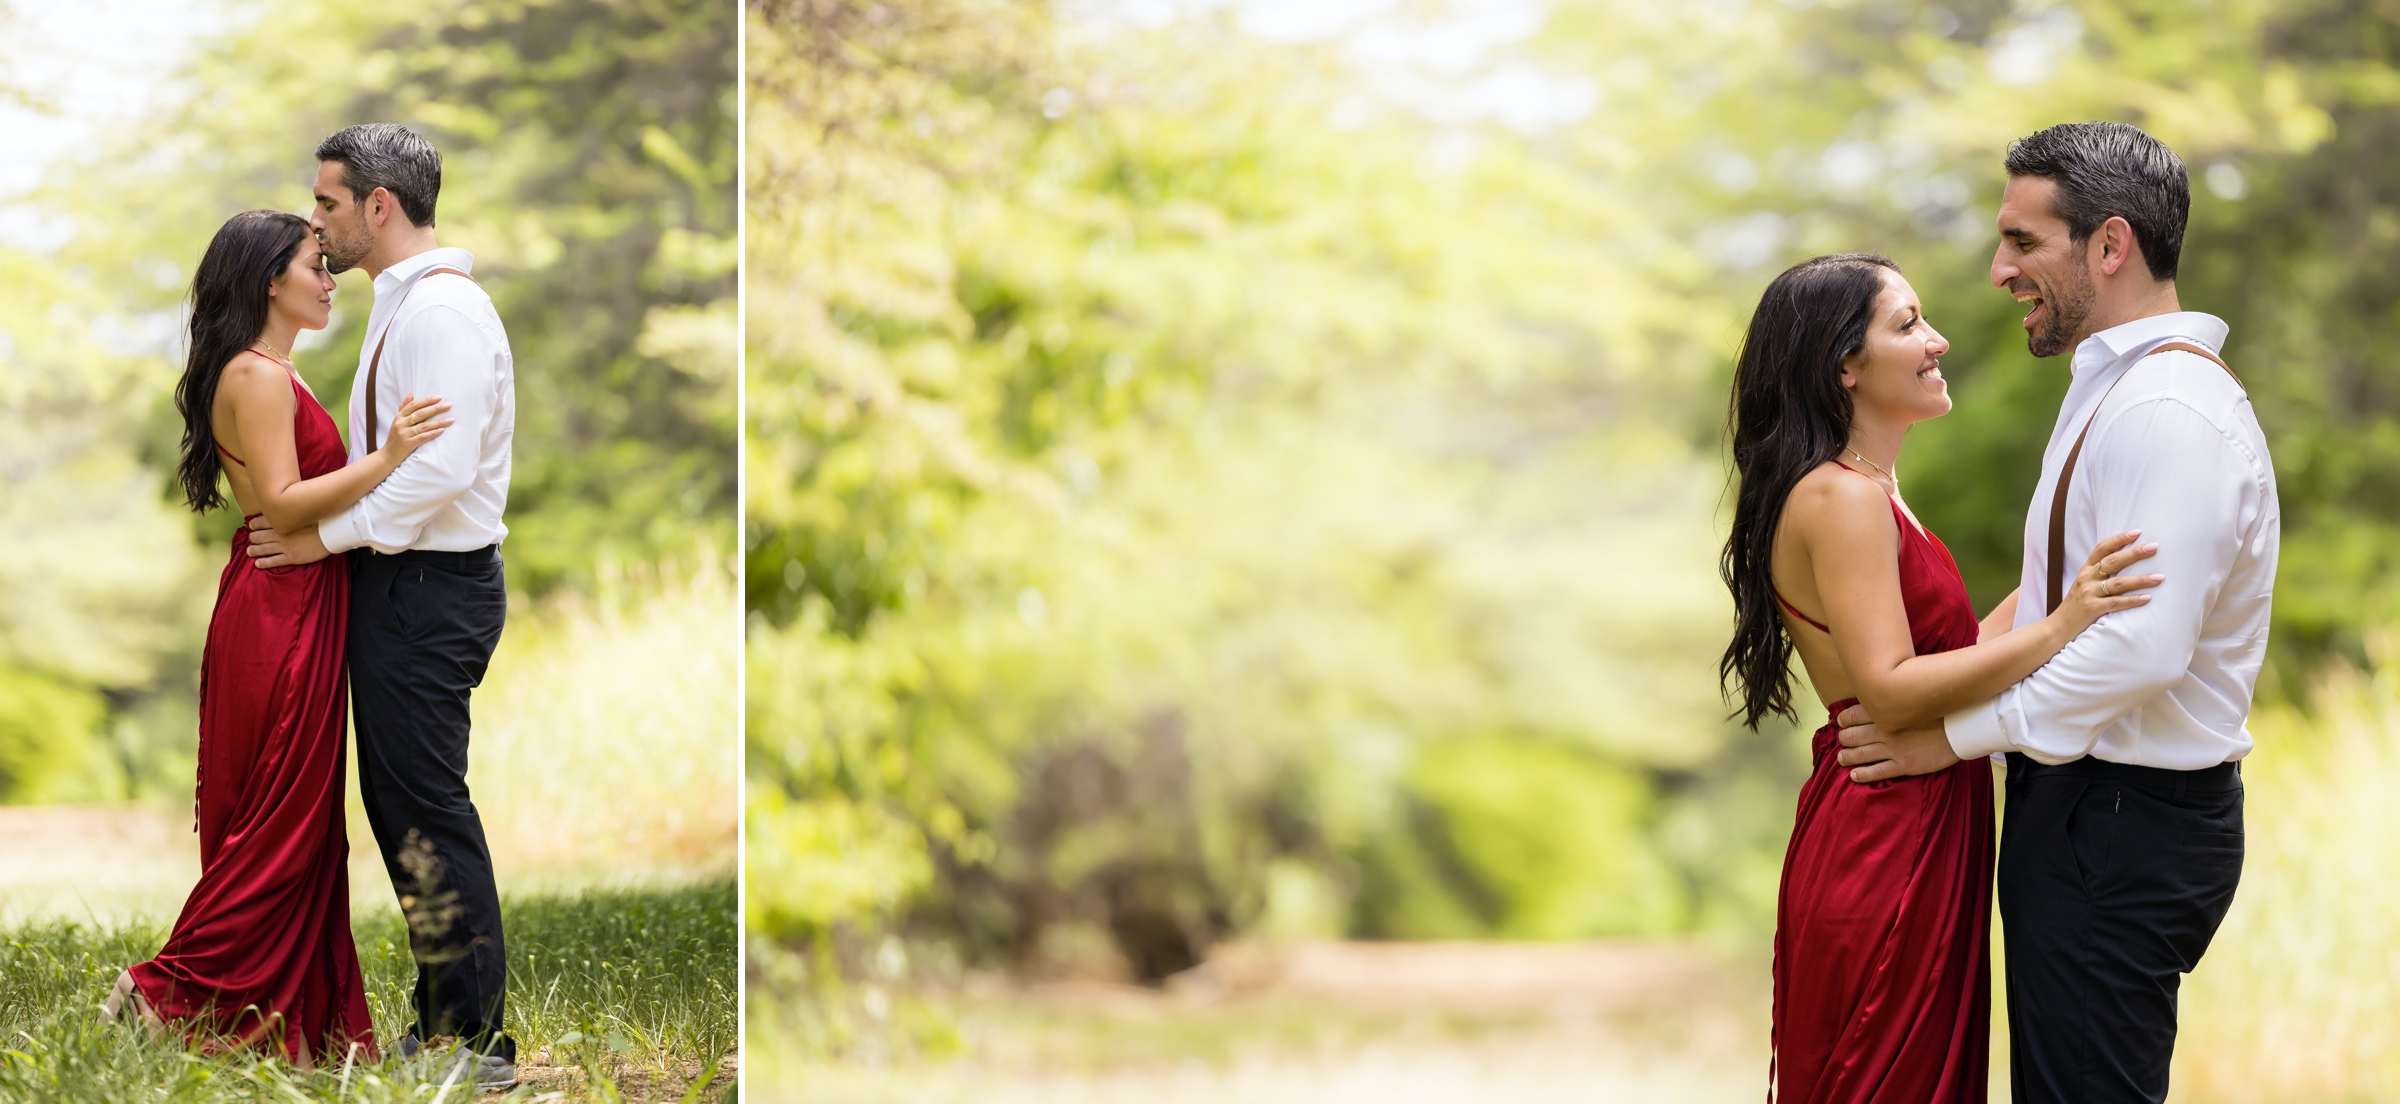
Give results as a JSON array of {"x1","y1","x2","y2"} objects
[{"x1": 1999, "y1": 754, "x2": 2242, "y2": 1104}]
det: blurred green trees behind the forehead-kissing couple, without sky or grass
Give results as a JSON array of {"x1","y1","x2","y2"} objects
[{"x1": 0, "y1": 0, "x2": 739, "y2": 799}]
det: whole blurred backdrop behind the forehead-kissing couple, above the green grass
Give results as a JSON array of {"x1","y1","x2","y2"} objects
[{"x1": 0, "y1": 0, "x2": 739, "y2": 922}]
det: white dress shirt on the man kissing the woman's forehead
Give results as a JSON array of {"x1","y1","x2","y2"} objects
[{"x1": 317, "y1": 250, "x2": 516, "y2": 561}]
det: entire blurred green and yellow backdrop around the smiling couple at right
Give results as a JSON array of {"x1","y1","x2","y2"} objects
[{"x1": 742, "y1": 0, "x2": 2400, "y2": 1102}]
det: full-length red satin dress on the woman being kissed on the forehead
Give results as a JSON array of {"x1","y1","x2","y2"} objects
[{"x1": 132, "y1": 377, "x2": 377, "y2": 1061}]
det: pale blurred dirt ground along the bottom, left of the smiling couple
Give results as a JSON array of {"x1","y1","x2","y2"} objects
[{"x1": 749, "y1": 943, "x2": 1766, "y2": 1104}]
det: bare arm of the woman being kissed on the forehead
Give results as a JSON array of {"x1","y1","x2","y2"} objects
[{"x1": 216, "y1": 353, "x2": 449, "y2": 533}]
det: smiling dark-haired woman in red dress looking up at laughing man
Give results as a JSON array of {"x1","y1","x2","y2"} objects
[{"x1": 1718, "y1": 254, "x2": 2162, "y2": 1104}]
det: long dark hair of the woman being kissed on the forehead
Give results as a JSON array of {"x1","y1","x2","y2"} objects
[{"x1": 175, "y1": 211, "x2": 310, "y2": 514}]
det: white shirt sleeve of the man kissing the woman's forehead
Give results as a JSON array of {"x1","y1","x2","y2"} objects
[{"x1": 317, "y1": 305, "x2": 499, "y2": 552}]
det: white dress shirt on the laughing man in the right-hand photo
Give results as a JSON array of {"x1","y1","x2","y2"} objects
[{"x1": 1946, "y1": 312, "x2": 2282, "y2": 770}]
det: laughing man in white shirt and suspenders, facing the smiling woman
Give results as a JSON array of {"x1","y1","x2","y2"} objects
[{"x1": 1841, "y1": 122, "x2": 2280, "y2": 1104}]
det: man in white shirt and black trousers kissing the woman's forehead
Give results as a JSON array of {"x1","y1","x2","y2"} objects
[{"x1": 250, "y1": 122, "x2": 516, "y2": 1085}]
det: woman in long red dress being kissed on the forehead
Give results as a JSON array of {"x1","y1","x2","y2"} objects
[{"x1": 106, "y1": 211, "x2": 449, "y2": 1066}]
